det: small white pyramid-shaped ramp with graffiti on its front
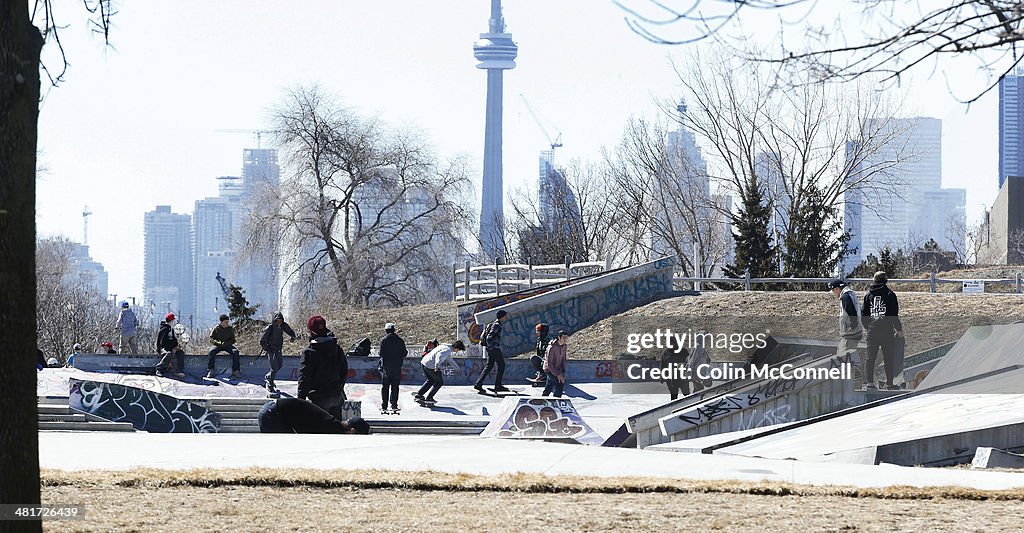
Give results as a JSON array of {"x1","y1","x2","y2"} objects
[{"x1": 480, "y1": 397, "x2": 604, "y2": 446}]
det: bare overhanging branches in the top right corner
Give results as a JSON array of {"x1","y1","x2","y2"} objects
[{"x1": 615, "y1": 0, "x2": 1024, "y2": 103}]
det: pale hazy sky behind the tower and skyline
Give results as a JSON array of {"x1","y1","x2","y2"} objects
[{"x1": 37, "y1": 0, "x2": 998, "y2": 300}]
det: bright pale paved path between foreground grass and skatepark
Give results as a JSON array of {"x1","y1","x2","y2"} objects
[{"x1": 39, "y1": 432, "x2": 1024, "y2": 490}]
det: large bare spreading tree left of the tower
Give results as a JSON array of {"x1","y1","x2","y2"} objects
[{"x1": 245, "y1": 87, "x2": 468, "y2": 306}]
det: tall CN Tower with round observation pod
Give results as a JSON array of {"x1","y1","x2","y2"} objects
[{"x1": 473, "y1": 0, "x2": 519, "y2": 259}]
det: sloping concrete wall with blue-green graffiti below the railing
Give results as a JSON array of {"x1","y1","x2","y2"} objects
[{"x1": 474, "y1": 257, "x2": 676, "y2": 356}]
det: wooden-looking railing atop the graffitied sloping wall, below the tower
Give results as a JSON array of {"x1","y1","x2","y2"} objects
[{"x1": 452, "y1": 257, "x2": 610, "y2": 302}]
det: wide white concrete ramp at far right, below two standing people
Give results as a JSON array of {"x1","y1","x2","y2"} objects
[{"x1": 714, "y1": 366, "x2": 1024, "y2": 465}]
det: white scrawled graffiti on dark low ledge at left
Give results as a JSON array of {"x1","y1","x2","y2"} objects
[{"x1": 70, "y1": 379, "x2": 221, "y2": 433}]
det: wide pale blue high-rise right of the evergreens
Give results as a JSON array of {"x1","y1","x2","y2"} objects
[{"x1": 843, "y1": 117, "x2": 967, "y2": 272}]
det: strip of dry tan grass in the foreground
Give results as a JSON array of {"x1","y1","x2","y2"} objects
[{"x1": 43, "y1": 470, "x2": 1024, "y2": 532}]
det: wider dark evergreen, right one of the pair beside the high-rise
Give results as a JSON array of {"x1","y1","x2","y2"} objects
[{"x1": 782, "y1": 185, "x2": 851, "y2": 277}]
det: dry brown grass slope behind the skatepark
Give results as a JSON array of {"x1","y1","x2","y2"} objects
[{"x1": 239, "y1": 288, "x2": 1024, "y2": 359}]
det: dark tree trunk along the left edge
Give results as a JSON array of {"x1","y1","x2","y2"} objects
[{"x1": 0, "y1": 0, "x2": 43, "y2": 531}]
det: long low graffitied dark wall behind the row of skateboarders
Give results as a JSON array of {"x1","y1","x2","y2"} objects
[{"x1": 75, "y1": 354, "x2": 623, "y2": 385}]
